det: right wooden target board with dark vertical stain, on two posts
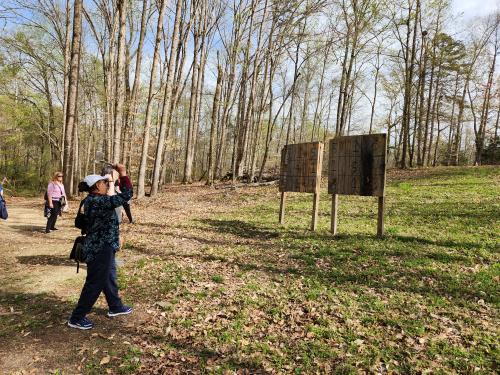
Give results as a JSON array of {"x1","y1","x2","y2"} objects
[{"x1": 328, "y1": 134, "x2": 387, "y2": 236}]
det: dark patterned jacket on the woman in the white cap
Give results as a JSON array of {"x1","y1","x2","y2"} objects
[{"x1": 83, "y1": 176, "x2": 133, "y2": 263}]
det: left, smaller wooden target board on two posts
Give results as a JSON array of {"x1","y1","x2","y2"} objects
[{"x1": 279, "y1": 142, "x2": 324, "y2": 230}]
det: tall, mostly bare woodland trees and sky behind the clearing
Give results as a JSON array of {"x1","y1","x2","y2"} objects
[{"x1": 0, "y1": 0, "x2": 500, "y2": 197}]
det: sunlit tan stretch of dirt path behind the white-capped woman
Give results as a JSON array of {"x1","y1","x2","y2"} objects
[{"x1": 0, "y1": 199, "x2": 85, "y2": 294}]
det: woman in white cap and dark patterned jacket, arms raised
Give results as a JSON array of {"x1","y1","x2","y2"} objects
[{"x1": 68, "y1": 164, "x2": 132, "y2": 329}]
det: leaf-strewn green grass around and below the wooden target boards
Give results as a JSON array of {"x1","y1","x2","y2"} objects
[{"x1": 122, "y1": 167, "x2": 500, "y2": 374}]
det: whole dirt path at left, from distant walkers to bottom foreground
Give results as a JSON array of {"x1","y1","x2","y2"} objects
[{"x1": 0, "y1": 199, "x2": 150, "y2": 374}]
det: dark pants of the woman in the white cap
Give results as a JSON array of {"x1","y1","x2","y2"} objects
[{"x1": 71, "y1": 247, "x2": 123, "y2": 320}]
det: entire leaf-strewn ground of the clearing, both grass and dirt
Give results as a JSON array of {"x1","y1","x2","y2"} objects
[{"x1": 0, "y1": 167, "x2": 500, "y2": 374}]
